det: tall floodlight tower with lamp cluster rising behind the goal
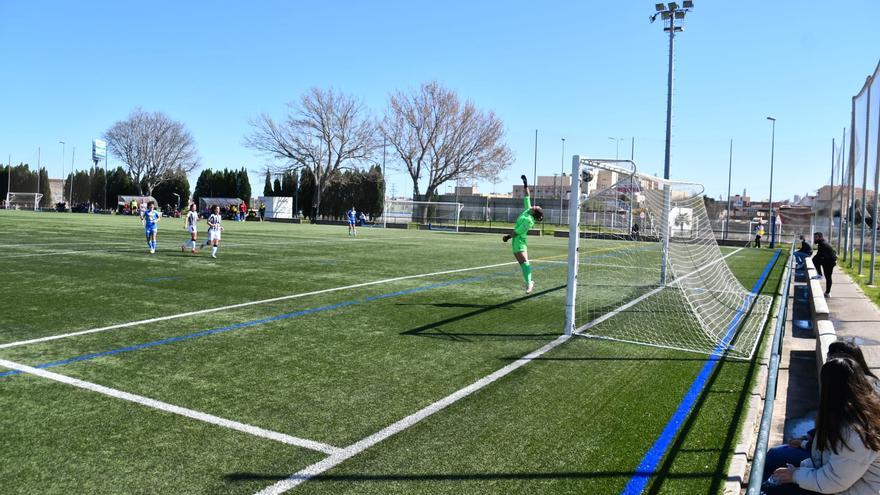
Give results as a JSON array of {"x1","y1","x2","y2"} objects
[{"x1": 650, "y1": 0, "x2": 694, "y2": 286}]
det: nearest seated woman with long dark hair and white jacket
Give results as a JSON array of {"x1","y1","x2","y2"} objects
[{"x1": 768, "y1": 357, "x2": 880, "y2": 495}]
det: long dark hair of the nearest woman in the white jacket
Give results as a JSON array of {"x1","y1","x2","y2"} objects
[{"x1": 816, "y1": 357, "x2": 880, "y2": 454}]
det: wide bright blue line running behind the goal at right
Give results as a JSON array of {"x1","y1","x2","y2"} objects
[{"x1": 620, "y1": 251, "x2": 780, "y2": 495}]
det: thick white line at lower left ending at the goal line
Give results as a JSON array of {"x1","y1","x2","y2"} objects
[{"x1": 0, "y1": 359, "x2": 342, "y2": 455}]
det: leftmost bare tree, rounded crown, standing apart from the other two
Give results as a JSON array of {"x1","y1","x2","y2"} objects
[{"x1": 104, "y1": 108, "x2": 199, "y2": 195}]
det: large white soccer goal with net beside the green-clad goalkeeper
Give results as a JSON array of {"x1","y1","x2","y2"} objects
[{"x1": 566, "y1": 156, "x2": 772, "y2": 359}]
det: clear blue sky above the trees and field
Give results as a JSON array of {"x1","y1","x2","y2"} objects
[{"x1": 0, "y1": 0, "x2": 880, "y2": 199}]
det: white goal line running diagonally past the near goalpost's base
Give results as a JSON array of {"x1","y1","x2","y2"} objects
[{"x1": 256, "y1": 248, "x2": 743, "y2": 495}]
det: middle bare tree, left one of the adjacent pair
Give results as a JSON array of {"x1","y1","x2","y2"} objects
[{"x1": 245, "y1": 88, "x2": 378, "y2": 214}]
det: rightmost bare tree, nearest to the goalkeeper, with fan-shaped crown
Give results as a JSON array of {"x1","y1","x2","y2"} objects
[{"x1": 381, "y1": 81, "x2": 513, "y2": 201}]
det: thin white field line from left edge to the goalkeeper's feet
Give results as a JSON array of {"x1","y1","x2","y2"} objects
[{"x1": 0, "y1": 261, "x2": 516, "y2": 349}]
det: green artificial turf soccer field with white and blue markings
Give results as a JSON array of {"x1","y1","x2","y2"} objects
[{"x1": 0, "y1": 211, "x2": 783, "y2": 495}]
